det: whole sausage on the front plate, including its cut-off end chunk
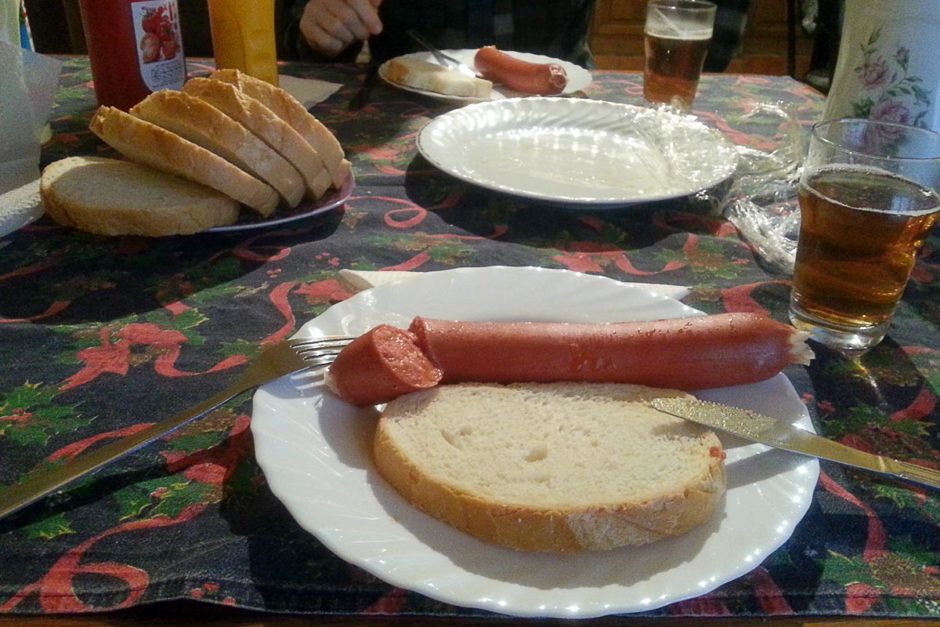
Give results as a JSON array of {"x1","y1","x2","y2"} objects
[{"x1": 328, "y1": 313, "x2": 812, "y2": 406}]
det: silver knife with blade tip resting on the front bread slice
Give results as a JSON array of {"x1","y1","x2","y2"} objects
[{"x1": 650, "y1": 398, "x2": 940, "y2": 489}]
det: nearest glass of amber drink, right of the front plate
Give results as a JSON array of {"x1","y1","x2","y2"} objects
[{"x1": 793, "y1": 167, "x2": 940, "y2": 327}]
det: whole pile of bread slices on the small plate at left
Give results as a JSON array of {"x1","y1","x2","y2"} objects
[{"x1": 40, "y1": 70, "x2": 351, "y2": 237}]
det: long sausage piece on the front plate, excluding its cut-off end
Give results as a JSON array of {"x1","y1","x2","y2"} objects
[{"x1": 410, "y1": 313, "x2": 812, "y2": 390}]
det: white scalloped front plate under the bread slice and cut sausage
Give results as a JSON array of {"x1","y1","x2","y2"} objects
[{"x1": 251, "y1": 267, "x2": 819, "y2": 618}]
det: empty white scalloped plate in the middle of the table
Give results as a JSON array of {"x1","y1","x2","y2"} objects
[{"x1": 417, "y1": 98, "x2": 738, "y2": 208}]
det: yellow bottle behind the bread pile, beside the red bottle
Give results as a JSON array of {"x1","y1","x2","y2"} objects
[{"x1": 209, "y1": 0, "x2": 278, "y2": 85}]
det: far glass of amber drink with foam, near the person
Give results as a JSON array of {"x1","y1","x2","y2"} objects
[{"x1": 643, "y1": 0, "x2": 716, "y2": 111}]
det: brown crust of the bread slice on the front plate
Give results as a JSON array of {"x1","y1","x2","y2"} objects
[{"x1": 373, "y1": 384, "x2": 725, "y2": 553}]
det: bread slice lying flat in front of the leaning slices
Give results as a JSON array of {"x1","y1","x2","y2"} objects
[{"x1": 39, "y1": 157, "x2": 239, "y2": 237}]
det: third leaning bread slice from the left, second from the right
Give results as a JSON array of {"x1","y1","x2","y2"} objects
[{"x1": 183, "y1": 78, "x2": 329, "y2": 199}]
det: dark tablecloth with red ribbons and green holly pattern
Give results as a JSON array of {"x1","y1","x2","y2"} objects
[{"x1": 0, "y1": 58, "x2": 940, "y2": 617}]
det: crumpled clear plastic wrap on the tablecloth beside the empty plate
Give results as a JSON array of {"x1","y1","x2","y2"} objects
[{"x1": 722, "y1": 102, "x2": 805, "y2": 275}]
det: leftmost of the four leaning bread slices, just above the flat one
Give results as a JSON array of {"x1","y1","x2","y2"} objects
[{"x1": 89, "y1": 107, "x2": 279, "y2": 216}]
